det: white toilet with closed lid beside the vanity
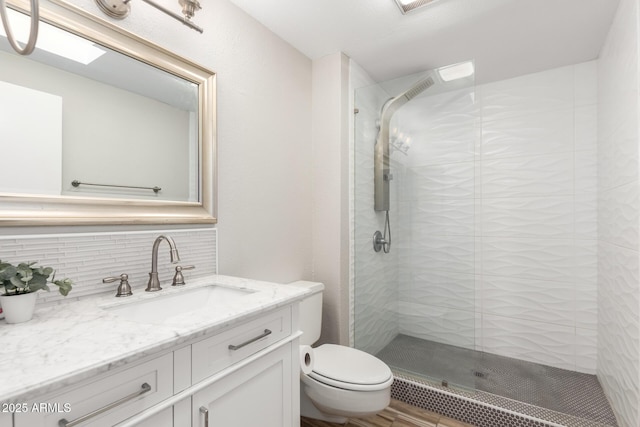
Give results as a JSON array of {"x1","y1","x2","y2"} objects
[{"x1": 291, "y1": 281, "x2": 393, "y2": 423}]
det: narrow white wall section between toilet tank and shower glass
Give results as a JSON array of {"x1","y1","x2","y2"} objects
[{"x1": 312, "y1": 53, "x2": 349, "y2": 344}]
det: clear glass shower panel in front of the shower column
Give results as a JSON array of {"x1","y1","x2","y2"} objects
[{"x1": 353, "y1": 67, "x2": 479, "y2": 387}]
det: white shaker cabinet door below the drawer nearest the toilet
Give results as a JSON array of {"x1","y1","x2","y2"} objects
[{"x1": 192, "y1": 343, "x2": 292, "y2": 427}]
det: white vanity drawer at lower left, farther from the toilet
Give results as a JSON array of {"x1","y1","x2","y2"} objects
[{"x1": 15, "y1": 353, "x2": 173, "y2": 427}]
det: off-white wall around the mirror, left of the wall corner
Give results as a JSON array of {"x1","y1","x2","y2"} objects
[{"x1": 1, "y1": 0, "x2": 311, "y2": 288}]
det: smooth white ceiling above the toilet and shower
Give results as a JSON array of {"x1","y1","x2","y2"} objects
[{"x1": 226, "y1": 0, "x2": 618, "y2": 83}]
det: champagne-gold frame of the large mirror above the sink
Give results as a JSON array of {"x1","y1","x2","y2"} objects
[{"x1": 0, "y1": 0, "x2": 217, "y2": 226}]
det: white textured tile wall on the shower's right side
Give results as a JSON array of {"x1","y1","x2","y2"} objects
[{"x1": 597, "y1": 0, "x2": 640, "y2": 427}]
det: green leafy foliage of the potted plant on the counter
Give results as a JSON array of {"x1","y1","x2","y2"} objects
[{"x1": 0, "y1": 261, "x2": 73, "y2": 296}]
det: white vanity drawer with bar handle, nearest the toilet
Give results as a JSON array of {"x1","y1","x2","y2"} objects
[{"x1": 191, "y1": 307, "x2": 291, "y2": 384}]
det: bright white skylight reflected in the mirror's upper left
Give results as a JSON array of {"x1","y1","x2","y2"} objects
[{"x1": 0, "y1": 9, "x2": 105, "y2": 65}]
